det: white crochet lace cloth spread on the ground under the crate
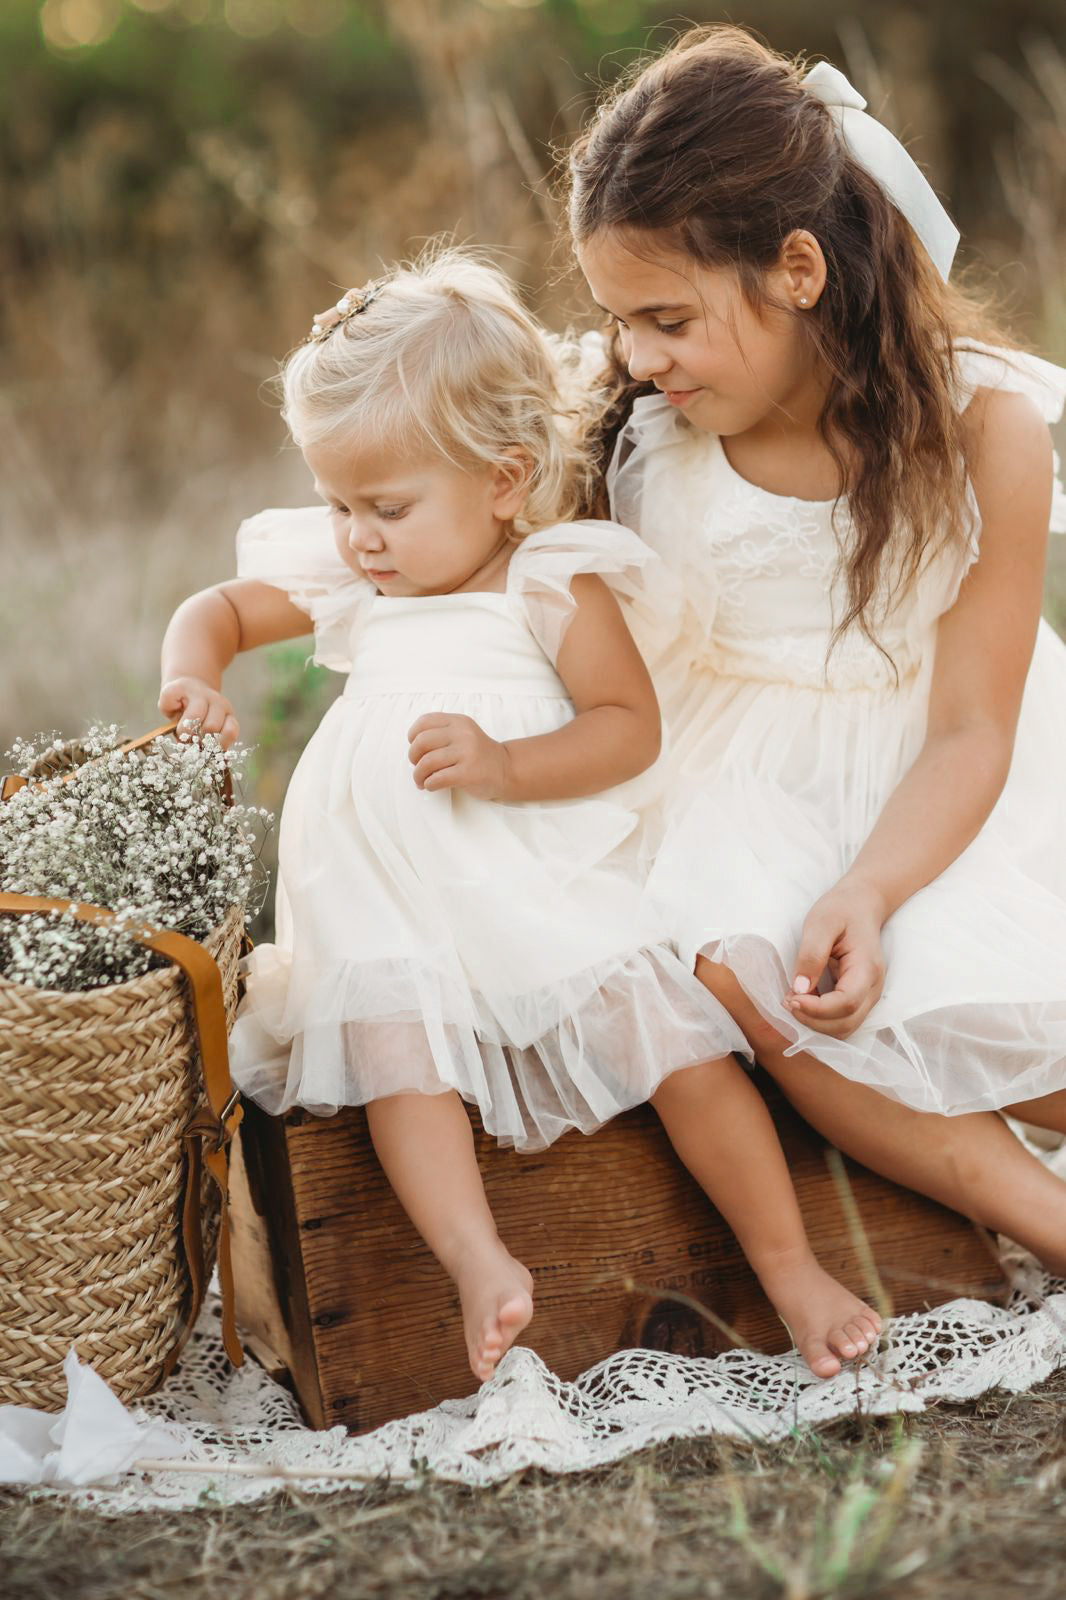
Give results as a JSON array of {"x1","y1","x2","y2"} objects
[{"x1": 43, "y1": 1150, "x2": 1066, "y2": 1512}]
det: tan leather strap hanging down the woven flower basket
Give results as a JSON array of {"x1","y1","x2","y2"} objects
[{"x1": 0, "y1": 896, "x2": 243, "y2": 1371}]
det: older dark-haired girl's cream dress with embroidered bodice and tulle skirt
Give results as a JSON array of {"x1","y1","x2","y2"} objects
[{"x1": 608, "y1": 346, "x2": 1066, "y2": 1114}]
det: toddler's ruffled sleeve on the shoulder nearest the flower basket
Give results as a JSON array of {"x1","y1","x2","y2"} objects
[{"x1": 237, "y1": 506, "x2": 375, "y2": 672}]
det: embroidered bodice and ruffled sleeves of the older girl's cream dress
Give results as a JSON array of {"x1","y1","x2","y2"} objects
[{"x1": 608, "y1": 340, "x2": 1066, "y2": 690}]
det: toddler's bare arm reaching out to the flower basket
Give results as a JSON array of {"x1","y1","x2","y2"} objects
[{"x1": 158, "y1": 578, "x2": 311, "y2": 749}]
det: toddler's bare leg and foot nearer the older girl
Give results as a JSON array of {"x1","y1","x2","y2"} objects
[{"x1": 651, "y1": 1056, "x2": 880, "y2": 1378}]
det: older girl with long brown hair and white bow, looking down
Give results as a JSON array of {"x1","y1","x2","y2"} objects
[{"x1": 571, "y1": 27, "x2": 1066, "y2": 1270}]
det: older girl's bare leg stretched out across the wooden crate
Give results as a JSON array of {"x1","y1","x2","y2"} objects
[{"x1": 696, "y1": 957, "x2": 1066, "y2": 1274}]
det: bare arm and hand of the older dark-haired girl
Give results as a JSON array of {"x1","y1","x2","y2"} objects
[{"x1": 791, "y1": 392, "x2": 1052, "y2": 1037}]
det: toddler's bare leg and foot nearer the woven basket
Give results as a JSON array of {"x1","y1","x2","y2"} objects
[{"x1": 367, "y1": 1093, "x2": 533, "y2": 1382}]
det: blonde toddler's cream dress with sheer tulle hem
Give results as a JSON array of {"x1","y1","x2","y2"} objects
[{"x1": 230, "y1": 507, "x2": 744, "y2": 1150}]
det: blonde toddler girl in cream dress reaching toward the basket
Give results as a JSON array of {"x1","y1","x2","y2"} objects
[{"x1": 160, "y1": 251, "x2": 879, "y2": 1379}]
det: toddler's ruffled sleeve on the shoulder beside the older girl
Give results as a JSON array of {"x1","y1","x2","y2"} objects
[{"x1": 507, "y1": 520, "x2": 682, "y2": 664}]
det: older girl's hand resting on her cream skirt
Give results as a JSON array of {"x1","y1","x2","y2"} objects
[{"x1": 784, "y1": 882, "x2": 885, "y2": 1038}]
